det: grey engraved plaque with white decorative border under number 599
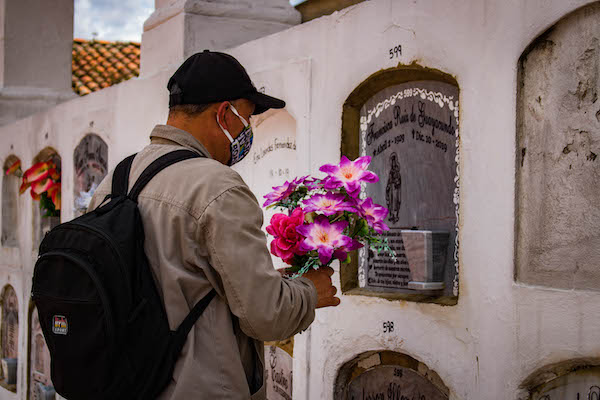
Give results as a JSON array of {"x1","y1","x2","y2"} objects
[{"x1": 359, "y1": 81, "x2": 458, "y2": 295}]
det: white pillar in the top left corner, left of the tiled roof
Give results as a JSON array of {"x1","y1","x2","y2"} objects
[{"x1": 0, "y1": 0, "x2": 75, "y2": 125}]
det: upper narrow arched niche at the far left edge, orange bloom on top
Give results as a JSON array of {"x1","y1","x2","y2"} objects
[{"x1": 1, "y1": 155, "x2": 22, "y2": 247}]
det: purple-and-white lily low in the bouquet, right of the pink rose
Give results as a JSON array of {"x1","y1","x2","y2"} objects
[{"x1": 296, "y1": 215, "x2": 352, "y2": 265}]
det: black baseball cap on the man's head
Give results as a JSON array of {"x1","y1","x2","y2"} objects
[{"x1": 167, "y1": 50, "x2": 285, "y2": 114}]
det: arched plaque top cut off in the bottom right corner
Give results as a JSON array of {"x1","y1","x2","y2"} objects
[{"x1": 532, "y1": 368, "x2": 600, "y2": 400}]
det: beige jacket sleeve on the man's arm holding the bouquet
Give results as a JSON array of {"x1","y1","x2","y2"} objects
[{"x1": 199, "y1": 186, "x2": 317, "y2": 341}]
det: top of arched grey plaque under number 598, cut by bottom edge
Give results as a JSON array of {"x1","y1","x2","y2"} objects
[{"x1": 348, "y1": 365, "x2": 448, "y2": 400}]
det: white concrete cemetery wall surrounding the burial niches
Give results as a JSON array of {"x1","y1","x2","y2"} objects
[{"x1": 0, "y1": 0, "x2": 600, "y2": 400}]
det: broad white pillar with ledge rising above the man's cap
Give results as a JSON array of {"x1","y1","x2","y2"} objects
[{"x1": 140, "y1": 0, "x2": 301, "y2": 76}]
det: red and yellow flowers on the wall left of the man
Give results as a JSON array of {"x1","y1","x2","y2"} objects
[{"x1": 19, "y1": 161, "x2": 61, "y2": 217}]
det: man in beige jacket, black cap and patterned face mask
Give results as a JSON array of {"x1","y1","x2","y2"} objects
[{"x1": 90, "y1": 50, "x2": 340, "y2": 400}]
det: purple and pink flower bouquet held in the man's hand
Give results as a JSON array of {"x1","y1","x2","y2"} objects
[{"x1": 263, "y1": 156, "x2": 395, "y2": 278}]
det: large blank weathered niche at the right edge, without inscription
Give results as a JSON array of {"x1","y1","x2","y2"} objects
[{"x1": 516, "y1": 2, "x2": 600, "y2": 289}]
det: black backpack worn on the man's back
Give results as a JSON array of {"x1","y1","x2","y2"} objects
[{"x1": 31, "y1": 150, "x2": 215, "y2": 400}]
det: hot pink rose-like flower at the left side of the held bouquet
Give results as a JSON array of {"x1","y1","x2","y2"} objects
[{"x1": 266, "y1": 208, "x2": 306, "y2": 264}]
